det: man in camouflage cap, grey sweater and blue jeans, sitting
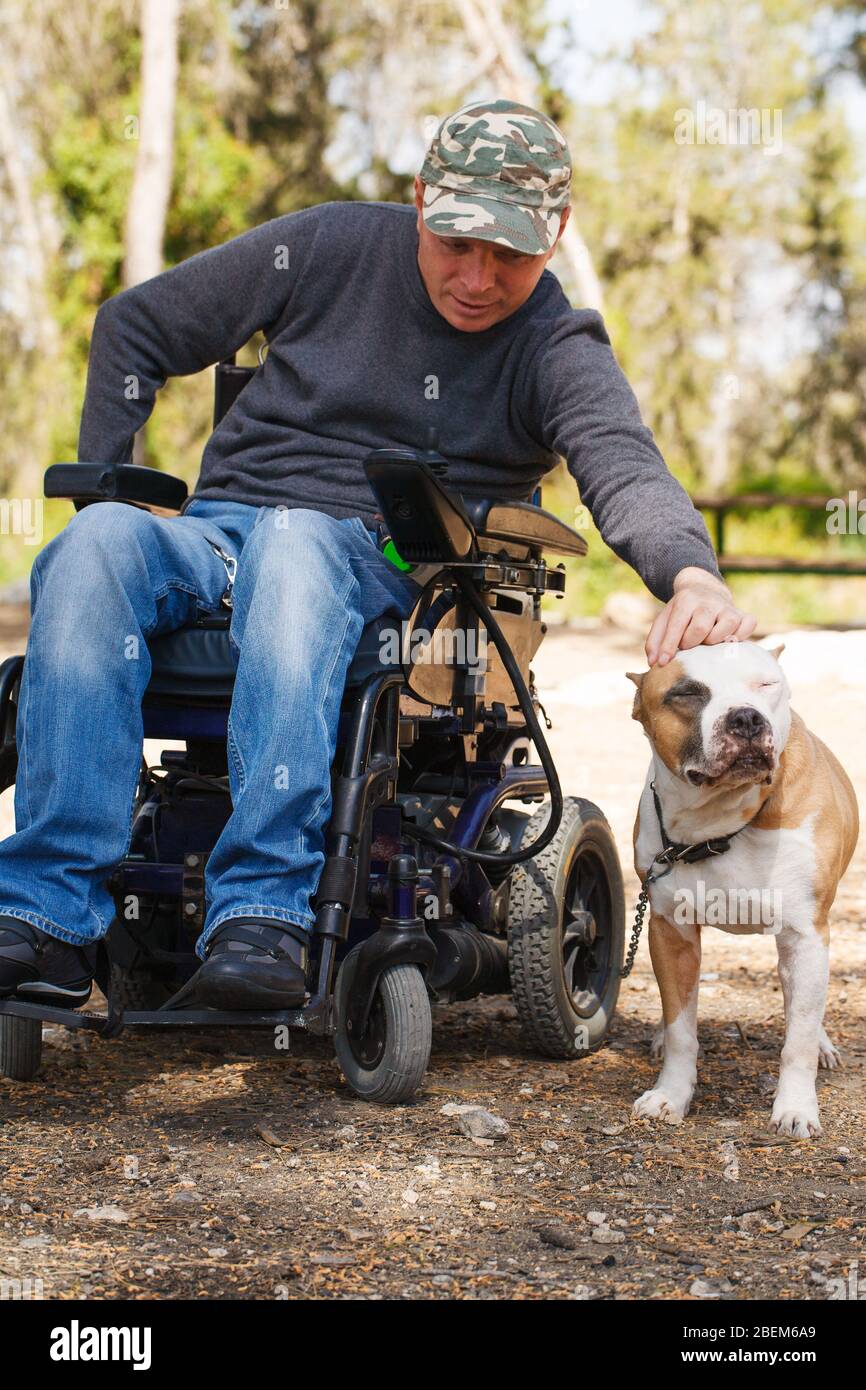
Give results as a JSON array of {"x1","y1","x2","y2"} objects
[{"x1": 0, "y1": 101, "x2": 755, "y2": 1008}]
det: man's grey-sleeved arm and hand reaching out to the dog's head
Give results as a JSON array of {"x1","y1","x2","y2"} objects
[{"x1": 525, "y1": 310, "x2": 755, "y2": 666}]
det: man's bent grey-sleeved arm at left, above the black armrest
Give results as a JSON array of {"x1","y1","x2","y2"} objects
[{"x1": 78, "y1": 210, "x2": 317, "y2": 463}]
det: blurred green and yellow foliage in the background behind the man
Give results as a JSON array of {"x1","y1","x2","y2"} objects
[{"x1": 0, "y1": 0, "x2": 866, "y2": 631}]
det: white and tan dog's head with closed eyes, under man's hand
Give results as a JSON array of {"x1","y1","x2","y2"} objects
[{"x1": 628, "y1": 642, "x2": 791, "y2": 788}]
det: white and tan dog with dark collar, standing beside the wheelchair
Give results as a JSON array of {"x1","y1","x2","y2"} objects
[{"x1": 628, "y1": 642, "x2": 859, "y2": 1138}]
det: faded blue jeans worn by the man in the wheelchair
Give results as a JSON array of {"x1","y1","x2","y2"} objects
[{"x1": 0, "y1": 499, "x2": 421, "y2": 958}]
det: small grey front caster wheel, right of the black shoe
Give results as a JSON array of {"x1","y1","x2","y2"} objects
[{"x1": 335, "y1": 947, "x2": 432, "y2": 1105}]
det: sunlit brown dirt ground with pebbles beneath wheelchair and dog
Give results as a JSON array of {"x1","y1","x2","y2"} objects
[{"x1": 0, "y1": 619, "x2": 866, "y2": 1298}]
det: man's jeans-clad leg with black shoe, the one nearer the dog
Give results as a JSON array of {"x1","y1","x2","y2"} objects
[{"x1": 195, "y1": 509, "x2": 420, "y2": 1008}]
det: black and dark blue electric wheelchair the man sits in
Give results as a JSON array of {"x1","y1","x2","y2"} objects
[{"x1": 0, "y1": 359, "x2": 626, "y2": 1104}]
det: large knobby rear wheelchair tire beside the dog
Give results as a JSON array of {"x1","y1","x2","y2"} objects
[{"x1": 509, "y1": 796, "x2": 626, "y2": 1058}]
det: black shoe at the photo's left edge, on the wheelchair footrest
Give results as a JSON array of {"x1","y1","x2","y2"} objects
[{"x1": 0, "y1": 915, "x2": 97, "y2": 1008}]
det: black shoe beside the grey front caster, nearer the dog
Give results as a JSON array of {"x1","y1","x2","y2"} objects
[{"x1": 183, "y1": 917, "x2": 309, "y2": 1011}]
